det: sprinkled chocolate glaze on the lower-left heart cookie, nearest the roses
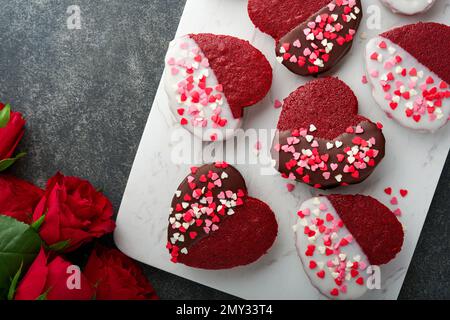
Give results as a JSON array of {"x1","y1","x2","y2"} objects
[{"x1": 167, "y1": 163, "x2": 247, "y2": 262}]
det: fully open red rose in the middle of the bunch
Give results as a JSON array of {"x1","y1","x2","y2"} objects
[{"x1": 33, "y1": 173, "x2": 115, "y2": 252}]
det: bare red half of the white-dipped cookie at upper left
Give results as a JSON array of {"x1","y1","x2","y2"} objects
[{"x1": 190, "y1": 33, "x2": 272, "y2": 118}]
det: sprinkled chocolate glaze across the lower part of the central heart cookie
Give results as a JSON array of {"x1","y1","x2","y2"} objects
[{"x1": 272, "y1": 121, "x2": 386, "y2": 189}]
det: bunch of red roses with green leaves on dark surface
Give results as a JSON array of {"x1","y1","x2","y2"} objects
[{"x1": 0, "y1": 103, "x2": 157, "y2": 300}]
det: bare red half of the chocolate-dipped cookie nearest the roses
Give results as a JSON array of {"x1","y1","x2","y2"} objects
[{"x1": 178, "y1": 197, "x2": 278, "y2": 270}]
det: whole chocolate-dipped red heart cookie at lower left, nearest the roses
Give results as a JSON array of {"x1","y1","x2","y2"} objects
[{"x1": 167, "y1": 162, "x2": 278, "y2": 270}]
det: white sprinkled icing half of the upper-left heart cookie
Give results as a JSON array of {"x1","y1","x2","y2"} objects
[{"x1": 164, "y1": 36, "x2": 240, "y2": 141}]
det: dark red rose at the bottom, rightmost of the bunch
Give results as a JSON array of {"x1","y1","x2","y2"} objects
[{"x1": 84, "y1": 246, "x2": 158, "y2": 300}]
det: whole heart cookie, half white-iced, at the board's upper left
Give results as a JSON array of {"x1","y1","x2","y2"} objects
[{"x1": 164, "y1": 34, "x2": 272, "y2": 141}]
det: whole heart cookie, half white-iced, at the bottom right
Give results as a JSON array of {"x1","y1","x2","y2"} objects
[{"x1": 294, "y1": 195, "x2": 404, "y2": 299}]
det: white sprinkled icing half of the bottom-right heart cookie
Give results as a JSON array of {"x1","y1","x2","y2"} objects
[{"x1": 294, "y1": 197, "x2": 369, "y2": 299}]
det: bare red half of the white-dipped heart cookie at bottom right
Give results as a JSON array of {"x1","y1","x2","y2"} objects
[{"x1": 327, "y1": 195, "x2": 404, "y2": 265}]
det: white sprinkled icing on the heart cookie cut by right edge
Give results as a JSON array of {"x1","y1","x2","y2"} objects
[{"x1": 365, "y1": 36, "x2": 450, "y2": 132}]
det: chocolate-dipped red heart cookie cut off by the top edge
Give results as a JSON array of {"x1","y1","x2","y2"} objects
[{"x1": 248, "y1": 0, "x2": 363, "y2": 76}]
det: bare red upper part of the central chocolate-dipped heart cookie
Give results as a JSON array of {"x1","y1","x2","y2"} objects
[{"x1": 277, "y1": 77, "x2": 369, "y2": 140}]
